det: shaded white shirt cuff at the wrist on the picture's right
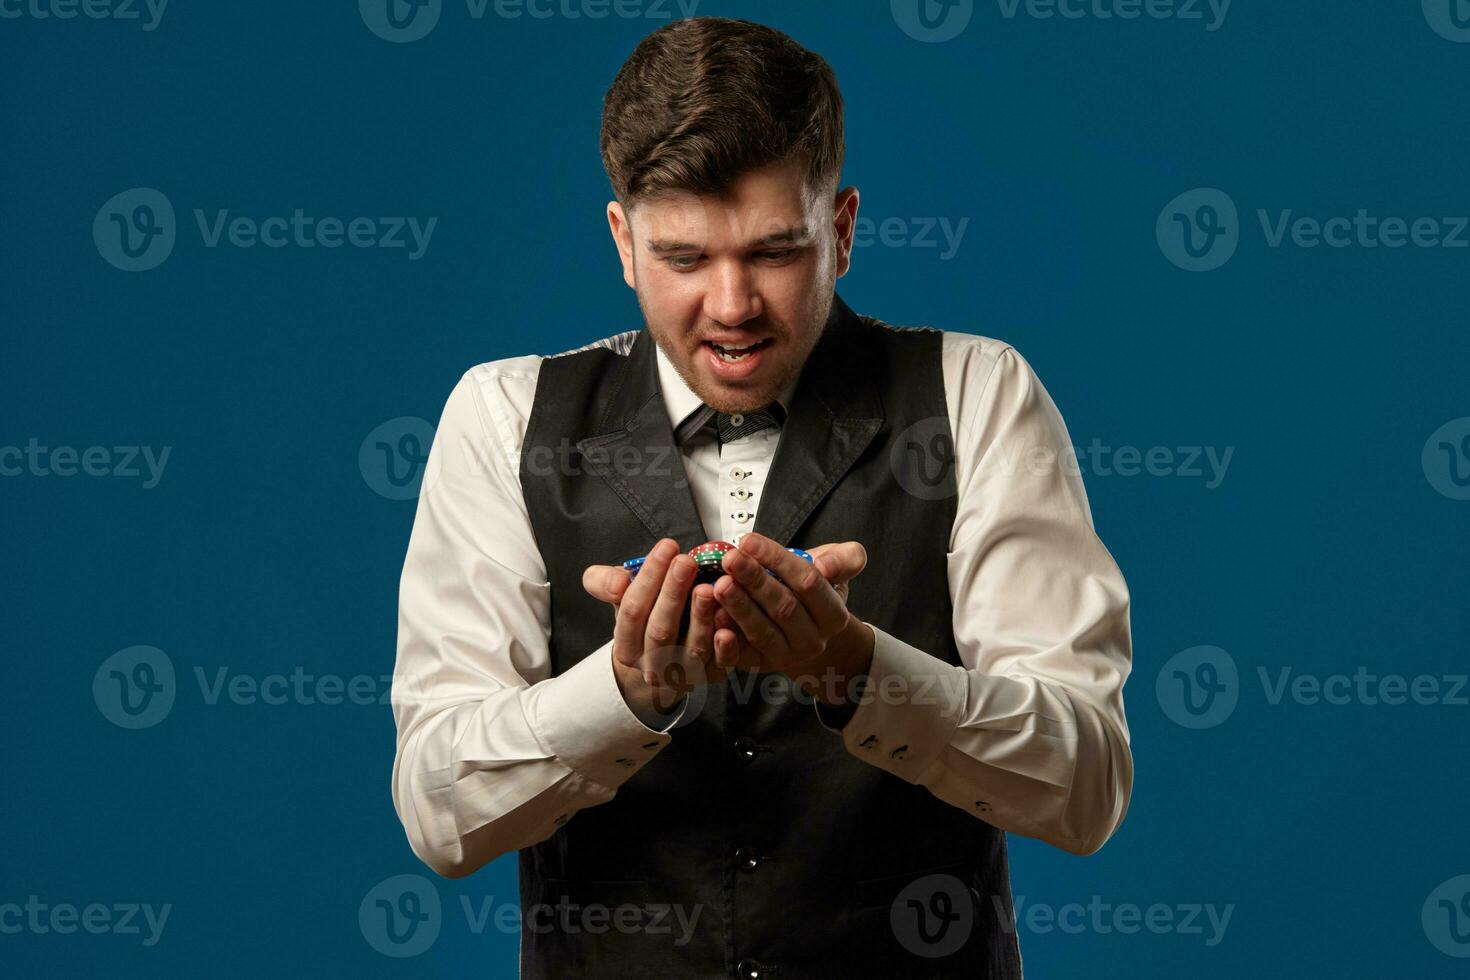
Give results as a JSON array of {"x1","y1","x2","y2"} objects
[{"x1": 817, "y1": 623, "x2": 969, "y2": 783}]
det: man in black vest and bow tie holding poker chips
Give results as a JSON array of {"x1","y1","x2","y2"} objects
[{"x1": 394, "y1": 18, "x2": 1132, "y2": 980}]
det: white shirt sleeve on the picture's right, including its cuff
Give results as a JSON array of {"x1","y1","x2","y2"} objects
[{"x1": 817, "y1": 335, "x2": 1133, "y2": 854}]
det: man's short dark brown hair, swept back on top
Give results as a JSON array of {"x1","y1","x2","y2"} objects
[{"x1": 600, "y1": 18, "x2": 842, "y2": 209}]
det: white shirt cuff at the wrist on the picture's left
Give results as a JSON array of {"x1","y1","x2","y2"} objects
[{"x1": 526, "y1": 641, "x2": 689, "y2": 786}]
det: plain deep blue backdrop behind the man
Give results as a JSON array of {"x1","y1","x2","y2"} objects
[{"x1": 0, "y1": 0, "x2": 1470, "y2": 980}]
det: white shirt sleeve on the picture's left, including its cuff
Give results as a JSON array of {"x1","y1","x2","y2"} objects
[{"x1": 392, "y1": 359, "x2": 682, "y2": 877}]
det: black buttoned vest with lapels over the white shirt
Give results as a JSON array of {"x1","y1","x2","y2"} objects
[{"x1": 520, "y1": 295, "x2": 1020, "y2": 980}]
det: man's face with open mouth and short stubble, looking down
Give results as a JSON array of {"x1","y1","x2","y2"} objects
[{"x1": 607, "y1": 163, "x2": 857, "y2": 411}]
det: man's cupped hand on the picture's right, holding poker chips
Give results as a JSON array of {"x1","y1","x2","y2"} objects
[{"x1": 714, "y1": 532, "x2": 873, "y2": 704}]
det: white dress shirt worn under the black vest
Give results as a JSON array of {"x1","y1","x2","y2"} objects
[{"x1": 392, "y1": 332, "x2": 1133, "y2": 877}]
